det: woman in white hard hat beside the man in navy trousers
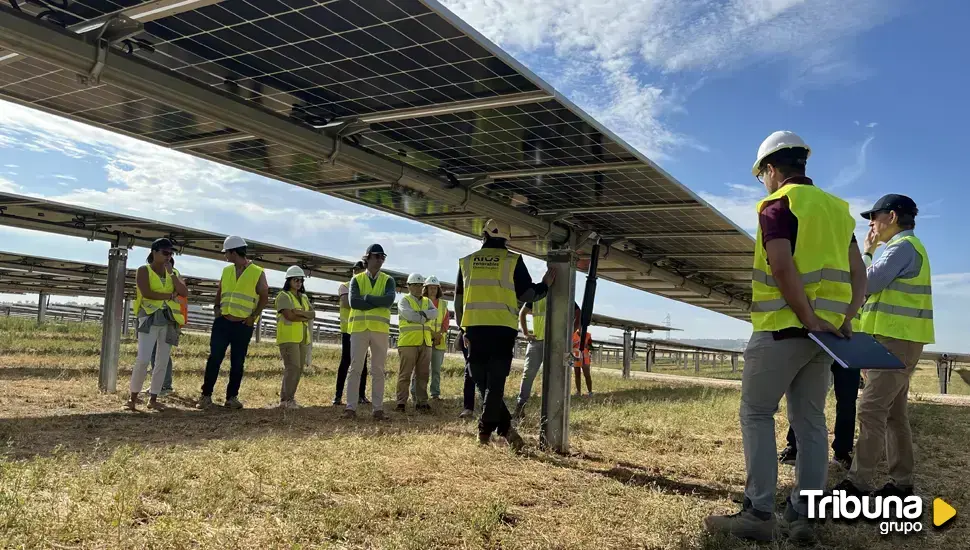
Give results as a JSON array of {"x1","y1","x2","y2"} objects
[{"x1": 276, "y1": 265, "x2": 316, "y2": 409}]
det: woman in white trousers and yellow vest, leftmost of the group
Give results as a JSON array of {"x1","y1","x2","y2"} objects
[{"x1": 126, "y1": 238, "x2": 188, "y2": 410}]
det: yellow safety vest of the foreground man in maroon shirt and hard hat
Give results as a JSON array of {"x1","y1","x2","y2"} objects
[{"x1": 751, "y1": 184, "x2": 855, "y2": 331}]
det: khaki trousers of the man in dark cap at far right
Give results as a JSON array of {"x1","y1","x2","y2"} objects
[{"x1": 849, "y1": 336, "x2": 923, "y2": 491}]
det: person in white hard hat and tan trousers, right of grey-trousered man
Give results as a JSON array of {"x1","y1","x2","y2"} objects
[{"x1": 397, "y1": 273, "x2": 438, "y2": 412}]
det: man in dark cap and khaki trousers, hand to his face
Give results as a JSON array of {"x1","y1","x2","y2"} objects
[{"x1": 836, "y1": 195, "x2": 935, "y2": 498}]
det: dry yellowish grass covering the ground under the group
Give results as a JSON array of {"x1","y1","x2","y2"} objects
[{"x1": 0, "y1": 320, "x2": 970, "y2": 549}]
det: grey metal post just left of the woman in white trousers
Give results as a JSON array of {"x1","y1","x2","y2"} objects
[{"x1": 98, "y1": 246, "x2": 128, "y2": 393}]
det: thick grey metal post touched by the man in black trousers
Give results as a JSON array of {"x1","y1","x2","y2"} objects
[{"x1": 539, "y1": 249, "x2": 576, "y2": 453}]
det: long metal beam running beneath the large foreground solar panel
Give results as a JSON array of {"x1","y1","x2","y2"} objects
[{"x1": 0, "y1": 4, "x2": 751, "y2": 311}]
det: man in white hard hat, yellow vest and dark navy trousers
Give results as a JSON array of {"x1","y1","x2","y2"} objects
[{"x1": 198, "y1": 235, "x2": 269, "y2": 409}]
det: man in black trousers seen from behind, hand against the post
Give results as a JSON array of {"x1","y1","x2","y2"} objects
[{"x1": 455, "y1": 220, "x2": 556, "y2": 451}]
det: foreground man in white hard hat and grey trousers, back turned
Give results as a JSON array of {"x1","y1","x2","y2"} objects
[{"x1": 704, "y1": 132, "x2": 866, "y2": 544}]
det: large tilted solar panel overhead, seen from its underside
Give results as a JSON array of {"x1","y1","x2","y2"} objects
[{"x1": 0, "y1": 0, "x2": 753, "y2": 318}]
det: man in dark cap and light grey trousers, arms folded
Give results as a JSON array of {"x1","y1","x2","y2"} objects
[{"x1": 344, "y1": 244, "x2": 396, "y2": 420}]
